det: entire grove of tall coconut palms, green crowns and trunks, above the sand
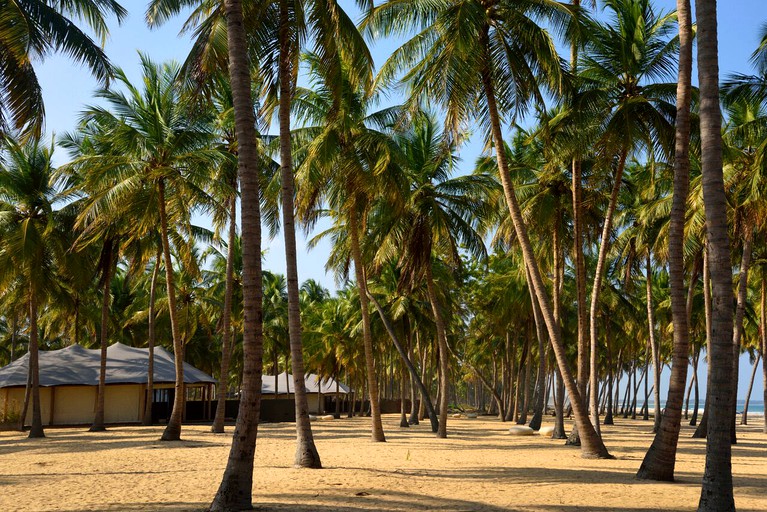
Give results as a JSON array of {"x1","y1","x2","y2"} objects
[{"x1": 0, "y1": 0, "x2": 767, "y2": 511}]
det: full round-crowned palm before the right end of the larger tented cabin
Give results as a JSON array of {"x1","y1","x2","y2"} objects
[{"x1": 61, "y1": 55, "x2": 221, "y2": 440}]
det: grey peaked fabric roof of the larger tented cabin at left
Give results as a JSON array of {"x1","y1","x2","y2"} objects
[{"x1": 0, "y1": 343, "x2": 216, "y2": 388}]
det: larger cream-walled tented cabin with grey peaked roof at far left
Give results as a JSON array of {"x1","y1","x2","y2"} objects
[{"x1": 0, "y1": 343, "x2": 216, "y2": 425}]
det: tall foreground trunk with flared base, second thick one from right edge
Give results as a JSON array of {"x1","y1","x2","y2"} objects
[{"x1": 637, "y1": 0, "x2": 697, "y2": 481}]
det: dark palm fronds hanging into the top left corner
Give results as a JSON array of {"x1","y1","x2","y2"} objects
[{"x1": 0, "y1": 0, "x2": 128, "y2": 137}]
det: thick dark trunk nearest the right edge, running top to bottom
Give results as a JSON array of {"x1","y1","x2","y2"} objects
[{"x1": 695, "y1": 0, "x2": 735, "y2": 506}]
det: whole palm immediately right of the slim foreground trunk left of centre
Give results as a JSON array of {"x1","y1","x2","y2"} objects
[{"x1": 294, "y1": 53, "x2": 399, "y2": 442}]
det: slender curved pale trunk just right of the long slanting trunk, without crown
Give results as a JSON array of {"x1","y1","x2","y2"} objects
[{"x1": 589, "y1": 149, "x2": 628, "y2": 435}]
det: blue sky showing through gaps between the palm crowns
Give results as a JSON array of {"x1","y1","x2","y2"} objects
[{"x1": 36, "y1": 0, "x2": 767, "y2": 399}]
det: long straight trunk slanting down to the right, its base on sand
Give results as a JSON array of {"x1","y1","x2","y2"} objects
[{"x1": 482, "y1": 45, "x2": 611, "y2": 458}]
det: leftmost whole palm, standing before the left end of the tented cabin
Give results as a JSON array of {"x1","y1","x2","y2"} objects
[{"x1": 0, "y1": 137, "x2": 71, "y2": 438}]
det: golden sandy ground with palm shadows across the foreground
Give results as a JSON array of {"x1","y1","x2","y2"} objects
[{"x1": 0, "y1": 415, "x2": 767, "y2": 512}]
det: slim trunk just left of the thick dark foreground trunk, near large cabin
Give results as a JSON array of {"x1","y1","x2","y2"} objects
[{"x1": 211, "y1": 194, "x2": 237, "y2": 434}]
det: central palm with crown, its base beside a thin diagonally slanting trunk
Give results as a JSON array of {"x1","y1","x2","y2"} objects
[{"x1": 380, "y1": 113, "x2": 495, "y2": 438}]
